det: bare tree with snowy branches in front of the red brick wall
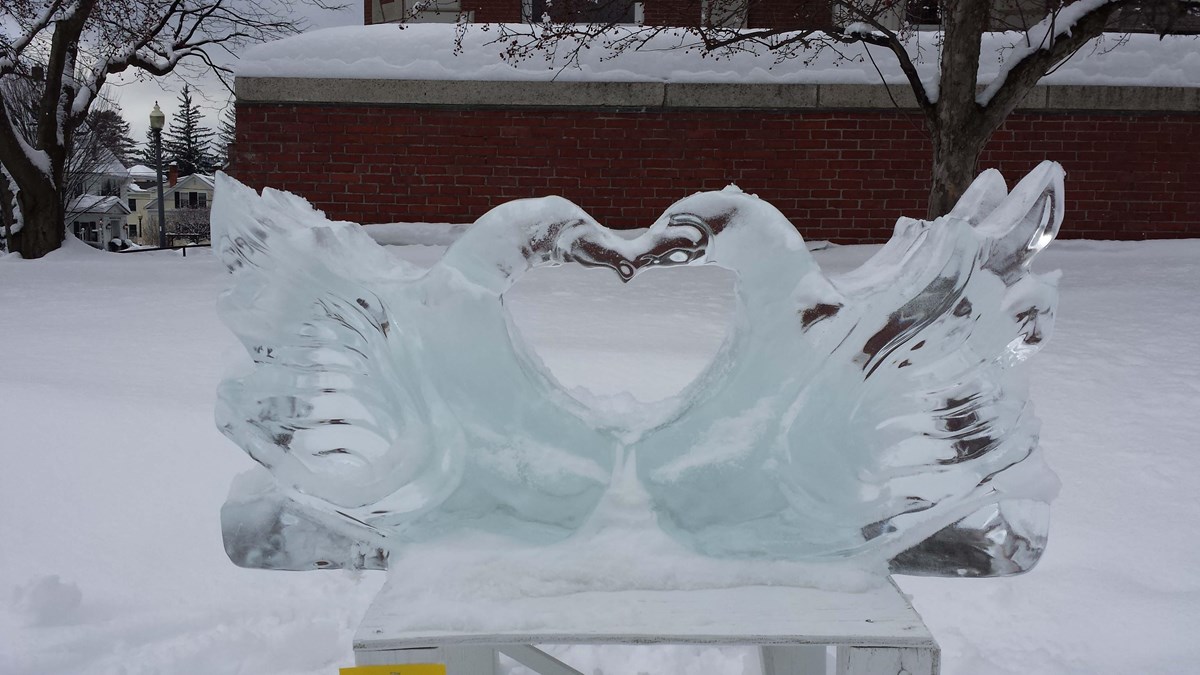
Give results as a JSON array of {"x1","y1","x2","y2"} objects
[{"x1": 487, "y1": 0, "x2": 1200, "y2": 217}]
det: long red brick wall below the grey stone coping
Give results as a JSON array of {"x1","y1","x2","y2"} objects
[{"x1": 233, "y1": 103, "x2": 1200, "y2": 243}]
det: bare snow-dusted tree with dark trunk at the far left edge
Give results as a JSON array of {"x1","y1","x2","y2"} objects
[{"x1": 0, "y1": 0, "x2": 343, "y2": 258}]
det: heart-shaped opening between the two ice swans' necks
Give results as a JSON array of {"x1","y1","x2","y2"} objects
[{"x1": 504, "y1": 264, "x2": 736, "y2": 406}]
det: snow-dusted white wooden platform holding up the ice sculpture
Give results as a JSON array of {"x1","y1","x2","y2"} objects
[{"x1": 354, "y1": 576, "x2": 940, "y2": 675}]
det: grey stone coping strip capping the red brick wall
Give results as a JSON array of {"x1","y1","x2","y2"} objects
[{"x1": 235, "y1": 77, "x2": 1200, "y2": 113}]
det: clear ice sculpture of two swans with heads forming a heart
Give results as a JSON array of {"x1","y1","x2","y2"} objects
[{"x1": 212, "y1": 162, "x2": 1063, "y2": 575}]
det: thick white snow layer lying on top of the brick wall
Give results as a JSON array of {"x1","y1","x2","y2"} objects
[{"x1": 238, "y1": 24, "x2": 1200, "y2": 86}]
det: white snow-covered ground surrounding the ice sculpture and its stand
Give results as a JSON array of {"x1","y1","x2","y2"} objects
[{"x1": 0, "y1": 233, "x2": 1200, "y2": 675}]
